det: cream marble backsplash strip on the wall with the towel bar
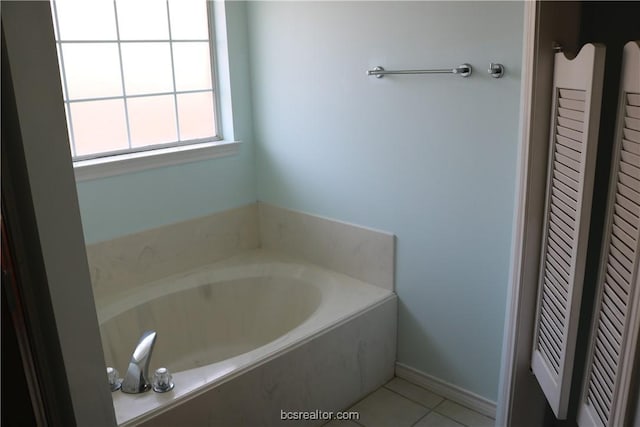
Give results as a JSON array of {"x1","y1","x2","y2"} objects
[{"x1": 258, "y1": 202, "x2": 395, "y2": 290}]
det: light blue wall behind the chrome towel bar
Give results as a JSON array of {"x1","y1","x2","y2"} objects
[{"x1": 248, "y1": 2, "x2": 523, "y2": 400}]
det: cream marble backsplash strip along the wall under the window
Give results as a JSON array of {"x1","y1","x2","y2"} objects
[{"x1": 87, "y1": 203, "x2": 260, "y2": 302}]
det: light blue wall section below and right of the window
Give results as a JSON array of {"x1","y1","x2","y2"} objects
[{"x1": 77, "y1": 2, "x2": 256, "y2": 243}]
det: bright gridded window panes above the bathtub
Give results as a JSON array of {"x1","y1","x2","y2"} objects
[{"x1": 51, "y1": 0, "x2": 221, "y2": 161}]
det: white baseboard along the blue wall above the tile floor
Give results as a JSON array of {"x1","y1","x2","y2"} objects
[{"x1": 396, "y1": 362, "x2": 496, "y2": 418}]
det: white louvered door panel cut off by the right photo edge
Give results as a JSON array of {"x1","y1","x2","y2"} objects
[{"x1": 578, "y1": 42, "x2": 640, "y2": 426}]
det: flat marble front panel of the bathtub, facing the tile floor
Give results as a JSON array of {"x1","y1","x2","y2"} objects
[{"x1": 139, "y1": 295, "x2": 397, "y2": 427}]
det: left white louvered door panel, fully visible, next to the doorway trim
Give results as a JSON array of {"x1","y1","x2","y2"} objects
[{"x1": 531, "y1": 44, "x2": 615, "y2": 419}]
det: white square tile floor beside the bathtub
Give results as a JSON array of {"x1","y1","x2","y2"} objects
[{"x1": 325, "y1": 377, "x2": 495, "y2": 427}]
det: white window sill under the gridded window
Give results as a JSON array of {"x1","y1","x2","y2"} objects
[{"x1": 73, "y1": 141, "x2": 240, "y2": 182}]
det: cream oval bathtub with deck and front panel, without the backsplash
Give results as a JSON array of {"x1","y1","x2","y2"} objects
[{"x1": 97, "y1": 250, "x2": 397, "y2": 426}]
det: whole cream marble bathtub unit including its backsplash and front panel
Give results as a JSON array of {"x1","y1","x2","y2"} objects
[{"x1": 87, "y1": 203, "x2": 397, "y2": 426}]
